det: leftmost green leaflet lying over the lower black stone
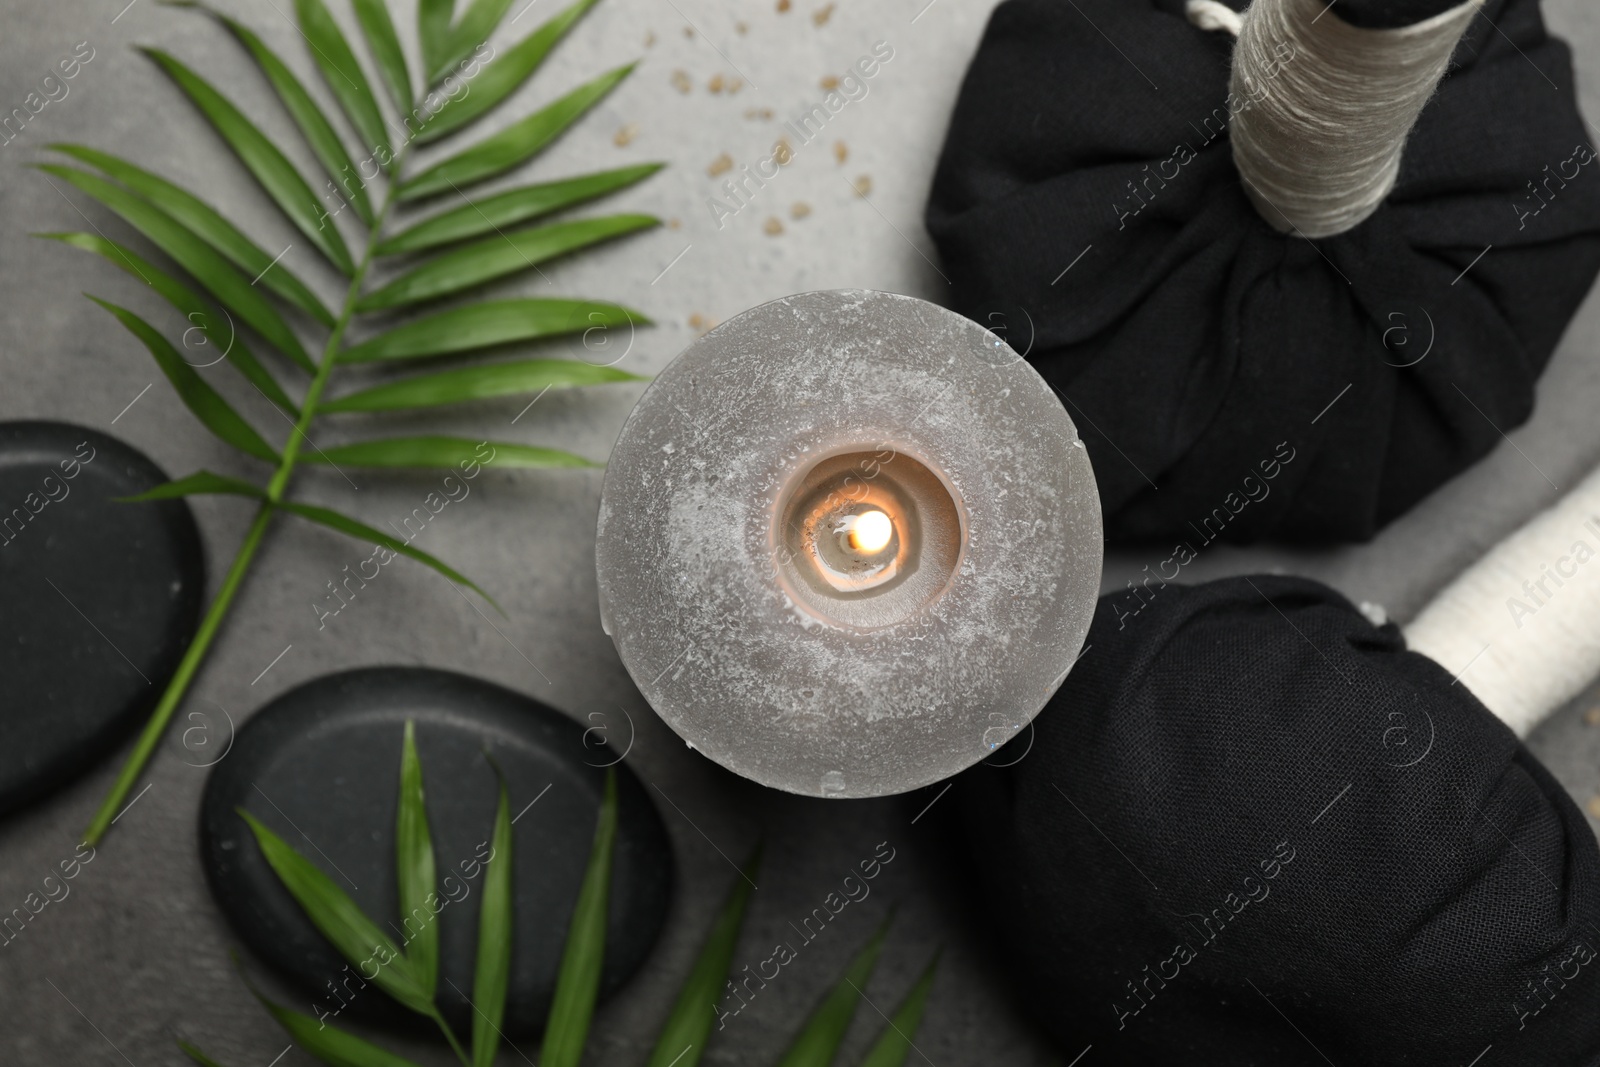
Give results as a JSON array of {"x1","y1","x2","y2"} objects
[{"x1": 238, "y1": 809, "x2": 434, "y2": 1033}]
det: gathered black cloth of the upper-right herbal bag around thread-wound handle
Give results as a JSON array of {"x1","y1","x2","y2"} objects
[{"x1": 926, "y1": 0, "x2": 1600, "y2": 542}]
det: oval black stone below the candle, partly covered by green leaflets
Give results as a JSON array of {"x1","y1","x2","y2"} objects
[{"x1": 200, "y1": 667, "x2": 672, "y2": 1040}]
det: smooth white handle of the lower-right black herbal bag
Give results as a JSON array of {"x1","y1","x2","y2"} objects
[{"x1": 1405, "y1": 470, "x2": 1600, "y2": 736}]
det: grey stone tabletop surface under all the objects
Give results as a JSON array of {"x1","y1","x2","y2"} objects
[{"x1": 0, "y1": 0, "x2": 1600, "y2": 1067}]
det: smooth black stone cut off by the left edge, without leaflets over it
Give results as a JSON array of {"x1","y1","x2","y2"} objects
[{"x1": 0, "y1": 422, "x2": 205, "y2": 811}]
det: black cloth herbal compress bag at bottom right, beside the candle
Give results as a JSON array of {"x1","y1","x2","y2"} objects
[{"x1": 944, "y1": 576, "x2": 1600, "y2": 1067}]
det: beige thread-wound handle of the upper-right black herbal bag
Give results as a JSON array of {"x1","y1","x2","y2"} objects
[{"x1": 1228, "y1": 0, "x2": 1483, "y2": 238}]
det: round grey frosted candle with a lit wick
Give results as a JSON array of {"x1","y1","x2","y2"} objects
[{"x1": 597, "y1": 290, "x2": 1102, "y2": 797}]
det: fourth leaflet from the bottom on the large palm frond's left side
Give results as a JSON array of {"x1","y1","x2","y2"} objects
[{"x1": 38, "y1": 163, "x2": 317, "y2": 373}]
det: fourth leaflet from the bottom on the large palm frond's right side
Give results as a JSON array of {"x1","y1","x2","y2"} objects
[{"x1": 339, "y1": 299, "x2": 650, "y2": 363}]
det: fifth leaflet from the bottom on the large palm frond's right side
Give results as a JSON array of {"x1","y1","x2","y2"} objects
[{"x1": 355, "y1": 214, "x2": 661, "y2": 312}]
